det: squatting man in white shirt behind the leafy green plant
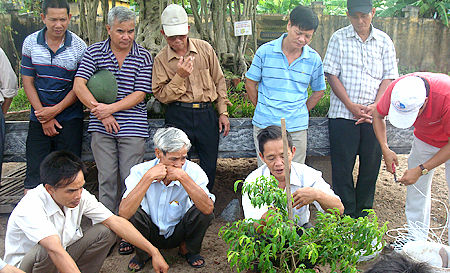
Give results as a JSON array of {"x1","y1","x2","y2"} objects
[{"x1": 242, "y1": 125, "x2": 344, "y2": 225}]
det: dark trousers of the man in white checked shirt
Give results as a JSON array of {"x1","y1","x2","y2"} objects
[{"x1": 328, "y1": 118, "x2": 381, "y2": 218}]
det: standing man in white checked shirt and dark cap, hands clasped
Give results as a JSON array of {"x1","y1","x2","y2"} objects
[{"x1": 323, "y1": 0, "x2": 398, "y2": 218}]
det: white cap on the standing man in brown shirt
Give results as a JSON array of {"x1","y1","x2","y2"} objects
[{"x1": 161, "y1": 4, "x2": 189, "y2": 36}]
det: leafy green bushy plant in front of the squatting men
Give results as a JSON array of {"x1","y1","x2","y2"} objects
[{"x1": 219, "y1": 176, "x2": 387, "y2": 273}]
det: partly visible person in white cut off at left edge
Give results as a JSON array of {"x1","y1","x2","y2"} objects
[{"x1": 0, "y1": 48, "x2": 18, "y2": 176}]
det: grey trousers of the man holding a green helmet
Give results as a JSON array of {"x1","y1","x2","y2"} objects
[{"x1": 91, "y1": 132, "x2": 145, "y2": 214}]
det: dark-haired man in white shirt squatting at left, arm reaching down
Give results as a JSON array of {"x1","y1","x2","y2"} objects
[{"x1": 5, "y1": 151, "x2": 169, "y2": 273}]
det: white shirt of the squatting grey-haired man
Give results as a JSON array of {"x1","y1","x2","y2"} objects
[{"x1": 122, "y1": 158, "x2": 216, "y2": 238}]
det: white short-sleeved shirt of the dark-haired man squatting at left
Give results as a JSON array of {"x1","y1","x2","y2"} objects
[{"x1": 5, "y1": 184, "x2": 113, "y2": 267}]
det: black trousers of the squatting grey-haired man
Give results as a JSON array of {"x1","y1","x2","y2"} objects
[{"x1": 130, "y1": 205, "x2": 214, "y2": 261}]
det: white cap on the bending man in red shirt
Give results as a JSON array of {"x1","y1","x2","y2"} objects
[{"x1": 389, "y1": 76, "x2": 427, "y2": 128}]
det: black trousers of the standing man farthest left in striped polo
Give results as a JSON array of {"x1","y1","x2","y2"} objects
[{"x1": 24, "y1": 118, "x2": 83, "y2": 189}]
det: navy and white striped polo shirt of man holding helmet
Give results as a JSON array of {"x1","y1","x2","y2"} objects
[{"x1": 75, "y1": 39, "x2": 153, "y2": 138}]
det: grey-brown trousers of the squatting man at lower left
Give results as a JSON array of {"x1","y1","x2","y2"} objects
[{"x1": 20, "y1": 224, "x2": 116, "y2": 273}]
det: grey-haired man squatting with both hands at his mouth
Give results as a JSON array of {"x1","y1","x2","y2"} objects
[{"x1": 119, "y1": 127, "x2": 215, "y2": 271}]
